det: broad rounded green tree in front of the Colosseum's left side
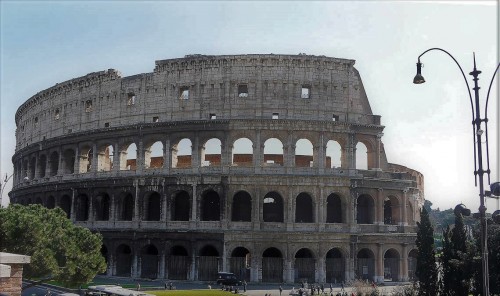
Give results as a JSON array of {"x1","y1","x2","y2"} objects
[{"x1": 0, "y1": 204, "x2": 106, "y2": 286}]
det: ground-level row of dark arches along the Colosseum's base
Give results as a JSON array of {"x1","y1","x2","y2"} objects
[{"x1": 101, "y1": 232, "x2": 416, "y2": 284}]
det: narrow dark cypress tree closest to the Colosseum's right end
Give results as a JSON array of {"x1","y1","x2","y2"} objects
[{"x1": 415, "y1": 207, "x2": 438, "y2": 296}]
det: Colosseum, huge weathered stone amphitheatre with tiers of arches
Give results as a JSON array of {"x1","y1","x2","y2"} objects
[{"x1": 10, "y1": 54, "x2": 424, "y2": 283}]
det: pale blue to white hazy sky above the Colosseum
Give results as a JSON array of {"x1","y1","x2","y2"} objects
[{"x1": 0, "y1": 0, "x2": 500, "y2": 212}]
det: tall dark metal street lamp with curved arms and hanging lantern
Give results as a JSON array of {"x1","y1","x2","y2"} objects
[{"x1": 413, "y1": 47, "x2": 500, "y2": 295}]
